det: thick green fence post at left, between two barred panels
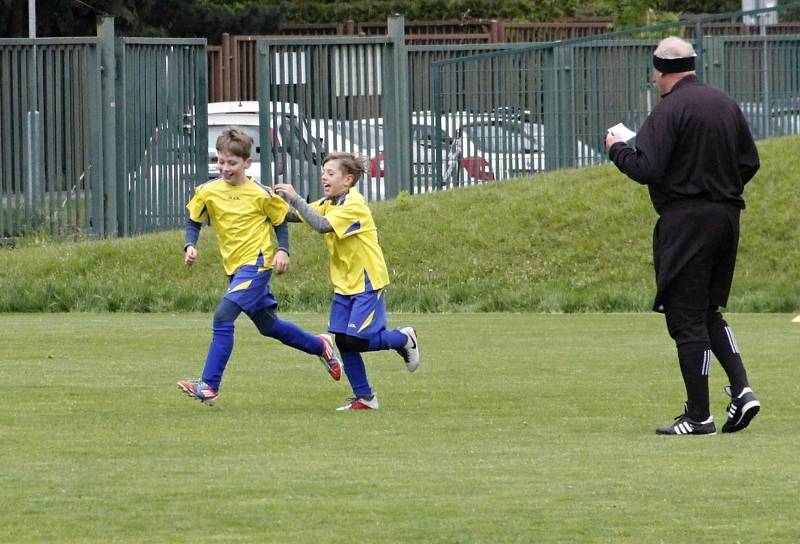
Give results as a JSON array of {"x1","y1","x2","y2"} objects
[{"x1": 95, "y1": 16, "x2": 118, "y2": 237}]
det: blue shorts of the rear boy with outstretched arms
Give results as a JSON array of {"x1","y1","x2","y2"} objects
[{"x1": 328, "y1": 289, "x2": 386, "y2": 340}]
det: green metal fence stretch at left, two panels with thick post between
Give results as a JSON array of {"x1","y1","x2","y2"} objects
[{"x1": 0, "y1": 17, "x2": 208, "y2": 243}]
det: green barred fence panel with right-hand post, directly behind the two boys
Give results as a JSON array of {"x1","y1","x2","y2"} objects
[{"x1": 256, "y1": 24, "x2": 410, "y2": 199}]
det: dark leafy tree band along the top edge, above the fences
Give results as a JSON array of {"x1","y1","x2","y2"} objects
[{"x1": 0, "y1": 0, "x2": 780, "y2": 38}]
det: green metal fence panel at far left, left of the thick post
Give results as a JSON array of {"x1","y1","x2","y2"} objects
[{"x1": 0, "y1": 38, "x2": 105, "y2": 238}]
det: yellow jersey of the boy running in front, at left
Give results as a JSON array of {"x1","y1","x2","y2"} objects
[{"x1": 186, "y1": 178, "x2": 289, "y2": 275}]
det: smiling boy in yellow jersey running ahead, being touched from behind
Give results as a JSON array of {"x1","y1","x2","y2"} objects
[{"x1": 178, "y1": 127, "x2": 341, "y2": 405}]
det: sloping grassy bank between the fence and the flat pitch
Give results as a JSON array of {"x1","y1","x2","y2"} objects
[{"x1": 0, "y1": 137, "x2": 800, "y2": 312}]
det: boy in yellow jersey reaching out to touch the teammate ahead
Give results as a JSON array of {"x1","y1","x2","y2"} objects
[{"x1": 275, "y1": 153, "x2": 419, "y2": 411}]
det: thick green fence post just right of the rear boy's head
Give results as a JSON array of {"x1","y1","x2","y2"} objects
[{"x1": 383, "y1": 15, "x2": 413, "y2": 198}]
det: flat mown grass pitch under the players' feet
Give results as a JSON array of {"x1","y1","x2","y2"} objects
[{"x1": 0, "y1": 313, "x2": 800, "y2": 544}]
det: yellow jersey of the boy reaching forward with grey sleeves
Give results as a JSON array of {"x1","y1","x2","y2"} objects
[{"x1": 310, "y1": 188, "x2": 389, "y2": 295}]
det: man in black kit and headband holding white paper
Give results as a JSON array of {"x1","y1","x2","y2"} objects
[{"x1": 606, "y1": 37, "x2": 761, "y2": 435}]
